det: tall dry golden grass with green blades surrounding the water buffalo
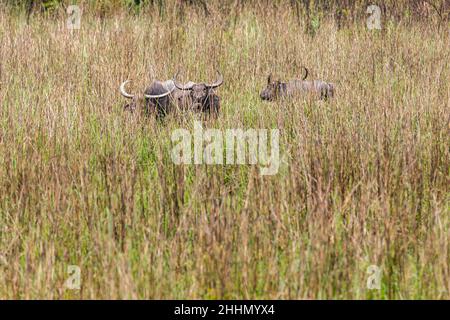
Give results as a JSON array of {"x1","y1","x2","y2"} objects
[{"x1": 0, "y1": 1, "x2": 450, "y2": 299}]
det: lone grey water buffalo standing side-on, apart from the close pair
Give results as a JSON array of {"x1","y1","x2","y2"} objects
[{"x1": 260, "y1": 67, "x2": 335, "y2": 101}]
